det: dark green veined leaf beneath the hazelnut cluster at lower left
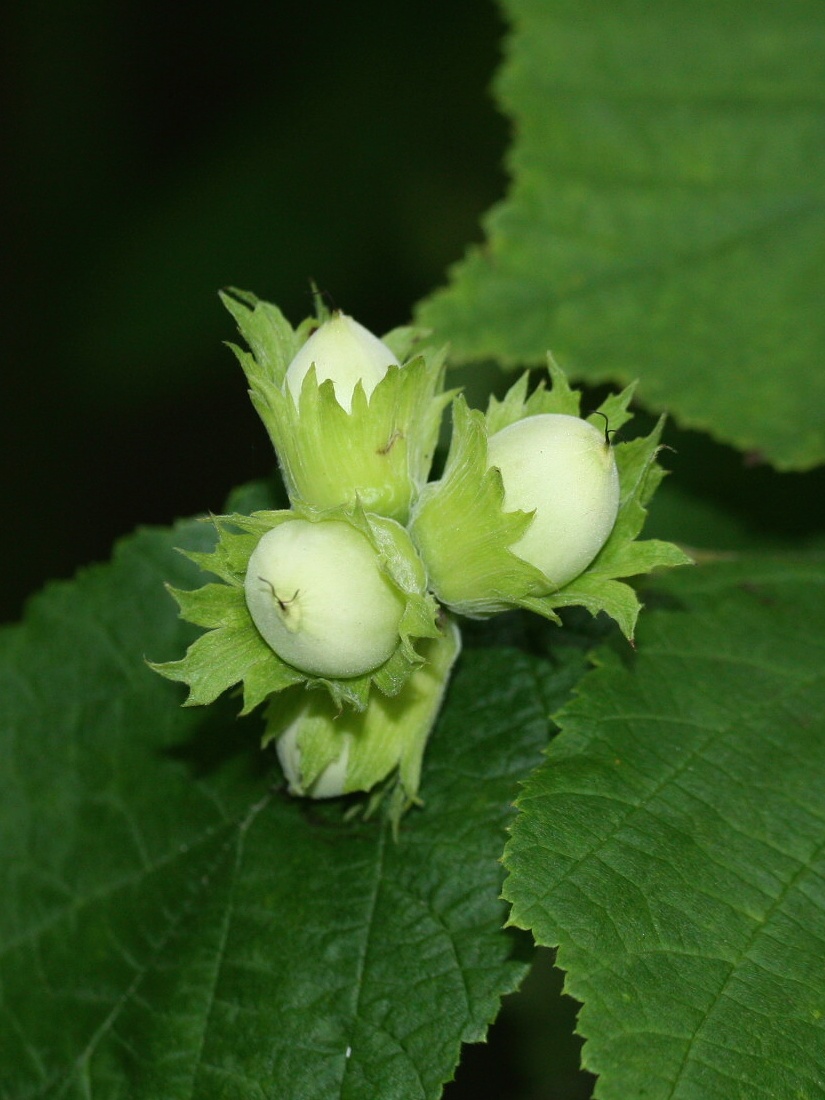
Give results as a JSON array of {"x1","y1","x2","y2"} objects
[{"x1": 0, "y1": 523, "x2": 583, "y2": 1100}]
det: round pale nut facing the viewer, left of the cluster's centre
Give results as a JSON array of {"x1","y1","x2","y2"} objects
[{"x1": 245, "y1": 519, "x2": 404, "y2": 679}]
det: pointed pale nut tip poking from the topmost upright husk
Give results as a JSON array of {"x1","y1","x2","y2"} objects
[{"x1": 285, "y1": 314, "x2": 398, "y2": 413}]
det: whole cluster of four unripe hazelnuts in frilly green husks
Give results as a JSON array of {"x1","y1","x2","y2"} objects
[{"x1": 154, "y1": 290, "x2": 688, "y2": 821}]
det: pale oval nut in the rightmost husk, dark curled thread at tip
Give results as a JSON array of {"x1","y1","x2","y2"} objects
[{"x1": 487, "y1": 413, "x2": 619, "y2": 587}]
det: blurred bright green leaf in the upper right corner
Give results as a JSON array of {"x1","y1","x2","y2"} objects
[{"x1": 418, "y1": 0, "x2": 825, "y2": 469}]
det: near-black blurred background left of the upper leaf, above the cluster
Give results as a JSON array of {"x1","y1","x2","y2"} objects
[{"x1": 0, "y1": 0, "x2": 508, "y2": 620}]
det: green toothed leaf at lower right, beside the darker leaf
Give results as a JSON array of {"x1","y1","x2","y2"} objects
[{"x1": 505, "y1": 556, "x2": 825, "y2": 1100}]
